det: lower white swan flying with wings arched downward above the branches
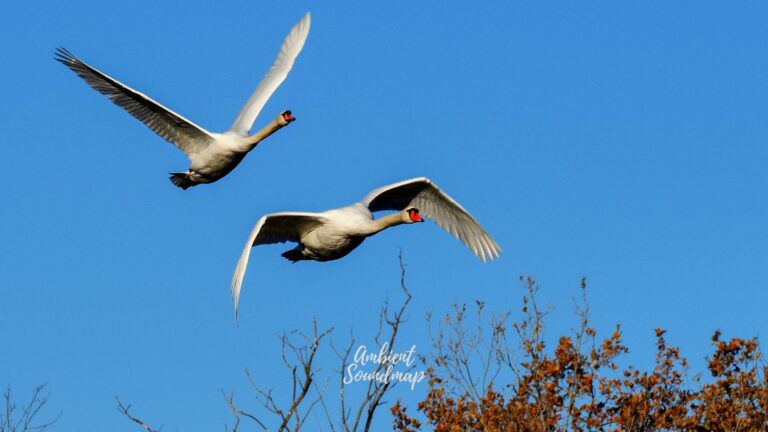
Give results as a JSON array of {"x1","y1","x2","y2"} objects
[{"x1": 231, "y1": 177, "x2": 501, "y2": 319}]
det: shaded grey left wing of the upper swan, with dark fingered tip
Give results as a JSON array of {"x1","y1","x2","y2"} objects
[{"x1": 54, "y1": 48, "x2": 213, "y2": 156}]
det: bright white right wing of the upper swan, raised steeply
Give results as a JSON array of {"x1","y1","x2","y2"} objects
[{"x1": 229, "y1": 12, "x2": 311, "y2": 136}]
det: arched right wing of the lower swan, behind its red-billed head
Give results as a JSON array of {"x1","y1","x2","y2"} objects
[{"x1": 363, "y1": 177, "x2": 501, "y2": 262}]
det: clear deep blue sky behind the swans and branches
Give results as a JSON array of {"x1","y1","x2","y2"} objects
[{"x1": 0, "y1": 0, "x2": 768, "y2": 431}]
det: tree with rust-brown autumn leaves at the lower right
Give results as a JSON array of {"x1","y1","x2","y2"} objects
[{"x1": 392, "y1": 278, "x2": 768, "y2": 432}]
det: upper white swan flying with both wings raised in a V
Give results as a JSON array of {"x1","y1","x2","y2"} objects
[{"x1": 54, "y1": 13, "x2": 310, "y2": 190}]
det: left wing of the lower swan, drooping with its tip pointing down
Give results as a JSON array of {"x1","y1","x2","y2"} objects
[{"x1": 231, "y1": 212, "x2": 326, "y2": 319}]
